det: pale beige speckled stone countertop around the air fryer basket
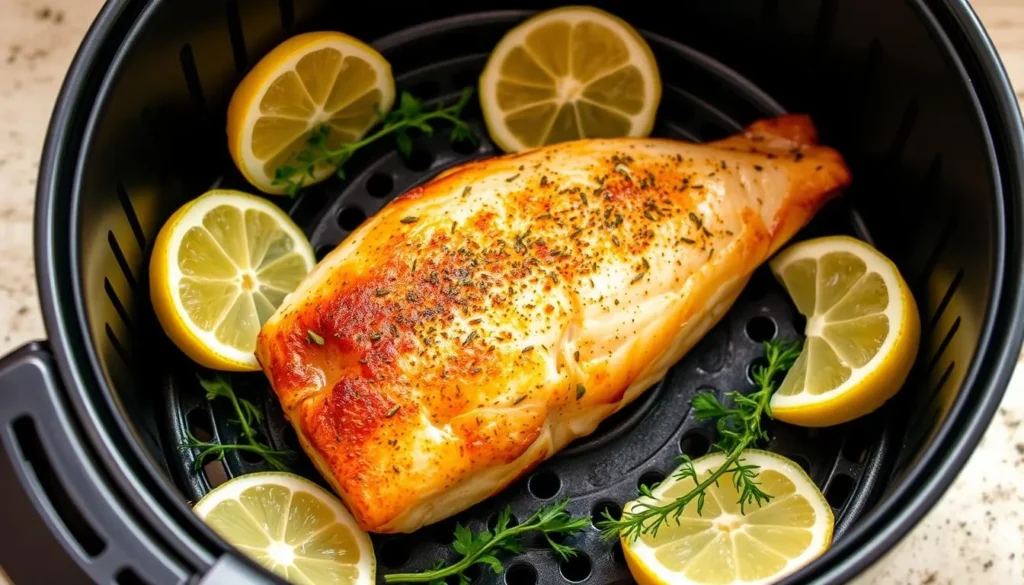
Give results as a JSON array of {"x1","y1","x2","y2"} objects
[{"x1": 0, "y1": 0, "x2": 1024, "y2": 585}]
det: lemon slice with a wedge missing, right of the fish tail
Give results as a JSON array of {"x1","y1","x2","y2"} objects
[{"x1": 770, "y1": 236, "x2": 921, "y2": 426}]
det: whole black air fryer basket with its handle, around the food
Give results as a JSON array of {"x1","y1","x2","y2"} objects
[{"x1": 0, "y1": 0, "x2": 1024, "y2": 585}]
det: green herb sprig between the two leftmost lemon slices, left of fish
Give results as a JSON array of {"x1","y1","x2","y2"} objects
[{"x1": 178, "y1": 376, "x2": 295, "y2": 471}]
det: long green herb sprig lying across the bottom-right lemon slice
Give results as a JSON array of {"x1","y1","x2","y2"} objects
[{"x1": 598, "y1": 341, "x2": 801, "y2": 540}]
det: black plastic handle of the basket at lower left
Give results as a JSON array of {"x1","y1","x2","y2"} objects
[{"x1": 0, "y1": 343, "x2": 193, "y2": 585}]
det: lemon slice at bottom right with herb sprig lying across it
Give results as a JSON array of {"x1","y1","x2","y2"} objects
[{"x1": 623, "y1": 449, "x2": 835, "y2": 585}]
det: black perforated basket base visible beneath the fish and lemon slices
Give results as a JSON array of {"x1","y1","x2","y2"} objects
[{"x1": 164, "y1": 12, "x2": 890, "y2": 585}]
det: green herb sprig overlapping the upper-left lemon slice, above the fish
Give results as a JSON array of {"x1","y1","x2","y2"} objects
[{"x1": 271, "y1": 87, "x2": 476, "y2": 197}]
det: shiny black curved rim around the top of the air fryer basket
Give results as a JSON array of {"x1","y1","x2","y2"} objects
[{"x1": 28, "y1": 0, "x2": 1024, "y2": 583}]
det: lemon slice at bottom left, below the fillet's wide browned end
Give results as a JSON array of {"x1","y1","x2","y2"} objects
[{"x1": 194, "y1": 471, "x2": 377, "y2": 585}]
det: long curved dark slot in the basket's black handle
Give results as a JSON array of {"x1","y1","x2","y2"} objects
[{"x1": 11, "y1": 416, "x2": 106, "y2": 558}]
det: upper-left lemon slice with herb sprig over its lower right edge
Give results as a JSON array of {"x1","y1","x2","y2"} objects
[{"x1": 227, "y1": 32, "x2": 394, "y2": 194}]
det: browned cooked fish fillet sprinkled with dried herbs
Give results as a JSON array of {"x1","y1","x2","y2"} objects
[{"x1": 257, "y1": 116, "x2": 850, "y2": 533}]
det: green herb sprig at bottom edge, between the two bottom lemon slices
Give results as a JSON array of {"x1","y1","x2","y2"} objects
[{"x1": 384, "y1": 501, "x2": 590, "y2": 585}]
